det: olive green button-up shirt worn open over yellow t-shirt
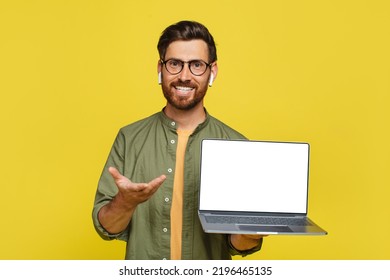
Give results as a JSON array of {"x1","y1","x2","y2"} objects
[{"x1": 93, "y1": 112, "x2": 261, "y2": 260}]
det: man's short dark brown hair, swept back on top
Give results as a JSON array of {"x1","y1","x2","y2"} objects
[{"x1": 157, "y1": 20, "x2": 217, "y2": 63}]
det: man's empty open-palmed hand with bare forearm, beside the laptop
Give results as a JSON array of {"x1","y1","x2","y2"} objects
[{"x1": 98, "y1": 167, "x2": 166, "y2": 234}]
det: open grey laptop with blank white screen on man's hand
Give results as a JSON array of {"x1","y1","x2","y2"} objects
[{"x1": 198, "y1": 139, "x2": 327, "y2": 235}]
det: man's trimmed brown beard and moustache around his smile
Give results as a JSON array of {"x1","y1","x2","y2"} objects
[{"x1": 161, "y1": 82, "x2": 207, "y2": 110}]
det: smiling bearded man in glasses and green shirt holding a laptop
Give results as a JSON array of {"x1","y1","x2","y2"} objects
[{"x1": 93, "y1": 21, "x2": 262, "y2": 259}]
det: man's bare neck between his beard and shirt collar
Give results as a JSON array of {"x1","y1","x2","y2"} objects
[{"x1": 164, "y1": 103, "x2": 206, "y2": 131}]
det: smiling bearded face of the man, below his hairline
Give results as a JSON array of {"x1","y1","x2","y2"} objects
[{"x1": 159, "y1": 40, "x2": 217, "y2": 110}]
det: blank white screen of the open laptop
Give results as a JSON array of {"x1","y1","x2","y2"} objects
[{"x1": 199, "y1": 139, "x2": 309, "y2": 214}]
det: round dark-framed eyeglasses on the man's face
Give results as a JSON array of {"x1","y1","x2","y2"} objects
[{"x1": 161, "y1": 59, "x2": 212, "y2": 76}]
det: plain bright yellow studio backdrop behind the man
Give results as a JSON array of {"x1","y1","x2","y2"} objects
[{"x1": 0, "y1": 0, "x2": 390, "y2": 259}]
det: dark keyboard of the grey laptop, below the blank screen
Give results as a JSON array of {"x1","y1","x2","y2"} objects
[{"x1": 205, "y1": 216, "x2": 310, "y2": 226}]
